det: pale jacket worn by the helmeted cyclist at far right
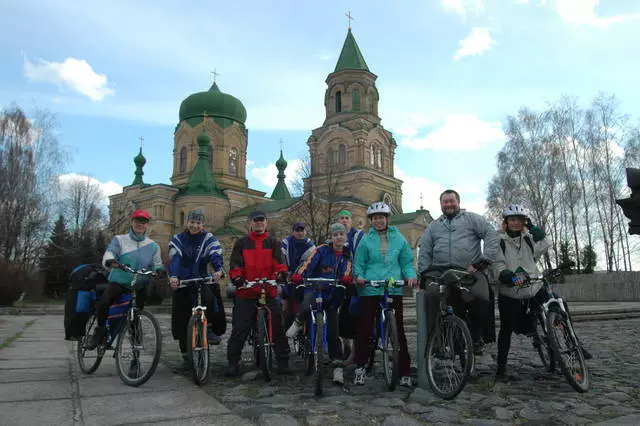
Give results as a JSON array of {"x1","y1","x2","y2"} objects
[{"x1": 491, "y1": 231, "x2": 551, "y2": 299}]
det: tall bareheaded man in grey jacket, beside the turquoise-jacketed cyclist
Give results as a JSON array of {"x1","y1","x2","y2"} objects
[{"x1": 418, "y1": 189, "x2": 500, "y2": 355}]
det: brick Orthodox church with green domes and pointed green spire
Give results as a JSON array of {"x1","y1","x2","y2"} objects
[{"x1": 109, "y1": 28, "x2": 432, "y2": 261}]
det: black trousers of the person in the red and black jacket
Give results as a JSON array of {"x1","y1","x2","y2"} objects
[{"x1": 227, "y1": 296, "x2": 289, "y2": 364}]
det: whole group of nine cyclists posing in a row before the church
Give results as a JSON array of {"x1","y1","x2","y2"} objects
[{"x1": 89, "y1": 186, "x2": 590, "y2": 387}]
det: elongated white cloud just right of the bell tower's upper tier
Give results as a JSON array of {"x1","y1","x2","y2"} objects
[{"x1": 400, "y1": 114, "x2": 504, "y2": 151}]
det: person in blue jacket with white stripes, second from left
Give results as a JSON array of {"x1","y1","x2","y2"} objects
[{"x1": 169, "y1": 210, "x2": 226, "y2": 368}]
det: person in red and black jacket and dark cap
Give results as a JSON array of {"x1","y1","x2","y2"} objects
[{"x1": 225, "y1": 211, "x2": 291, "y2": 377}]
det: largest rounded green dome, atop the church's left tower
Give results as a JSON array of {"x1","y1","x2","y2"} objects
[{"x1": 180, "y1": 83, "x2": 247, "y2": 124}]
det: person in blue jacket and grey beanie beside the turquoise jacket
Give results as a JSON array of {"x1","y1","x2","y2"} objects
[{"x1": 287, "y1": 223, "x2": 353, "y2": 384}]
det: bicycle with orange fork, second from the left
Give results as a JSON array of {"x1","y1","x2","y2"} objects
[{"x1": 178, "y1": 276, "x2": 216, "y2": 386}]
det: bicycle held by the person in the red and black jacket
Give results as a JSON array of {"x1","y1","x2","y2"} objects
[{"x1": 243, "y1": 278, "x2": 279, "y2": 382}]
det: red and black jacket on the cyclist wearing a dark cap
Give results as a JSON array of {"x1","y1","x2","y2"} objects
[{"x1": 229, "y1": 232, "x2": 287, "y2": 299}]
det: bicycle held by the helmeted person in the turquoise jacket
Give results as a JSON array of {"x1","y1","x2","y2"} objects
[{"x1": 365, "y1": 278, "x2": 405, "y2": 391}]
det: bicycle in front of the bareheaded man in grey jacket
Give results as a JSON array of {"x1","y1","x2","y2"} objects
[{"x1": 425, "y1": 269, "x2": 475, "y2": 400}]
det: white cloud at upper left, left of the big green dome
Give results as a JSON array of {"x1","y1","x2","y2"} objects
[{"x1": 24, "y1": 56, "x2": 114, "y2": 101}]
